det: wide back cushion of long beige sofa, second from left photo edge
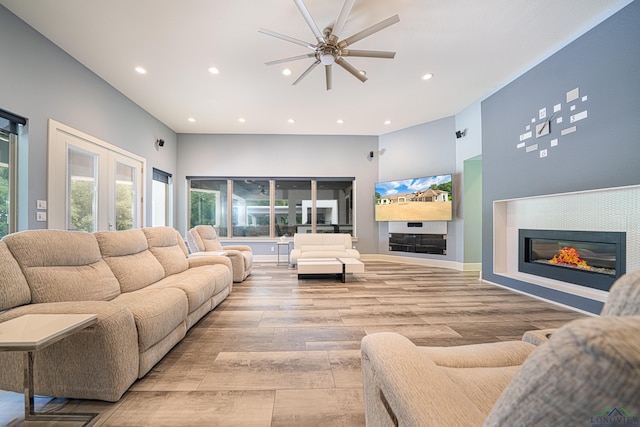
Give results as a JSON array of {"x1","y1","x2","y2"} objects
[{"x1": 4, "y1": 230, "x2": 120, "y2": 303}]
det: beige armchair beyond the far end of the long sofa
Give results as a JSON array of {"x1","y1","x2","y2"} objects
[{"x1": 187, "y1": 225, "x2": 253, "y2": 283}]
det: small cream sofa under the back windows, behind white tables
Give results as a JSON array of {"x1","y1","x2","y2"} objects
[{"x1": 290, "y1": 233, "x2": 360, "y2": 265}]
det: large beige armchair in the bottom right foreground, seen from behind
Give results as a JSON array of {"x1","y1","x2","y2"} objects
[{"x1": 362, "y1": 271, "x2": 640, "y2": 427}]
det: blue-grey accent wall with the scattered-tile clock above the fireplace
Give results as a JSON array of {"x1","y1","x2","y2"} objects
[{"x1": 482, "y1": 1, "x2": 640, "y2": 311}]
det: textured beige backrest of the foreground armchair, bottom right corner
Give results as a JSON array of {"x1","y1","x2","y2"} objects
[{"x1": 485, "y1": 316, "x2": 640, "y2": 426}]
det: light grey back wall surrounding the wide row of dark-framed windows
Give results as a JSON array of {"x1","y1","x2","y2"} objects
[{"x1": 174, "y1": 134, "x2": 378, "y2": 254}]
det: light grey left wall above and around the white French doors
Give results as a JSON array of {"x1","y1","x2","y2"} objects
[{"x1": 0, "y1": 6, "x2": 177, "y2": 230}]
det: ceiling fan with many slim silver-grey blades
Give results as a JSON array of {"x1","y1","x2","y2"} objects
[{"x1": 258, "y1": 0, "x2": 400, "y2": 90}]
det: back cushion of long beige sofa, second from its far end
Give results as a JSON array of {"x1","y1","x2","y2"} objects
[{"x1": 94, "y1": 230, "x2": 165, "y2": 292}]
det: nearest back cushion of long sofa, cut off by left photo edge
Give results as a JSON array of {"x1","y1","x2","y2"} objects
[{"x1": 0, "y1": 241, "x2": 31, "y2": 311}]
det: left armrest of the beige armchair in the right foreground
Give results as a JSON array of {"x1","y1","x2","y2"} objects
[{"x1": 361, "y1": 332, "x2": 484, "y2": 427}]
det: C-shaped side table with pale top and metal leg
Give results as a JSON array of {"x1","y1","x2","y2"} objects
[{"x1": 0, "y1": 314, "x2": 99, "y2": 426}]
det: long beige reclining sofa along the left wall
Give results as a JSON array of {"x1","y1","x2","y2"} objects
[{"x1": 0, "y1": 227, "x2": 233, "y2": 401}]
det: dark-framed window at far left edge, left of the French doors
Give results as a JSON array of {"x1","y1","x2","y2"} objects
[{"x1": 0, "y1": 110, "x2": 27, "y2": 238}]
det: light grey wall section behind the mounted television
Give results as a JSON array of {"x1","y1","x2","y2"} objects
[{"x1": 378, "y1": 116, "x2": 463, "y2": 262}]
